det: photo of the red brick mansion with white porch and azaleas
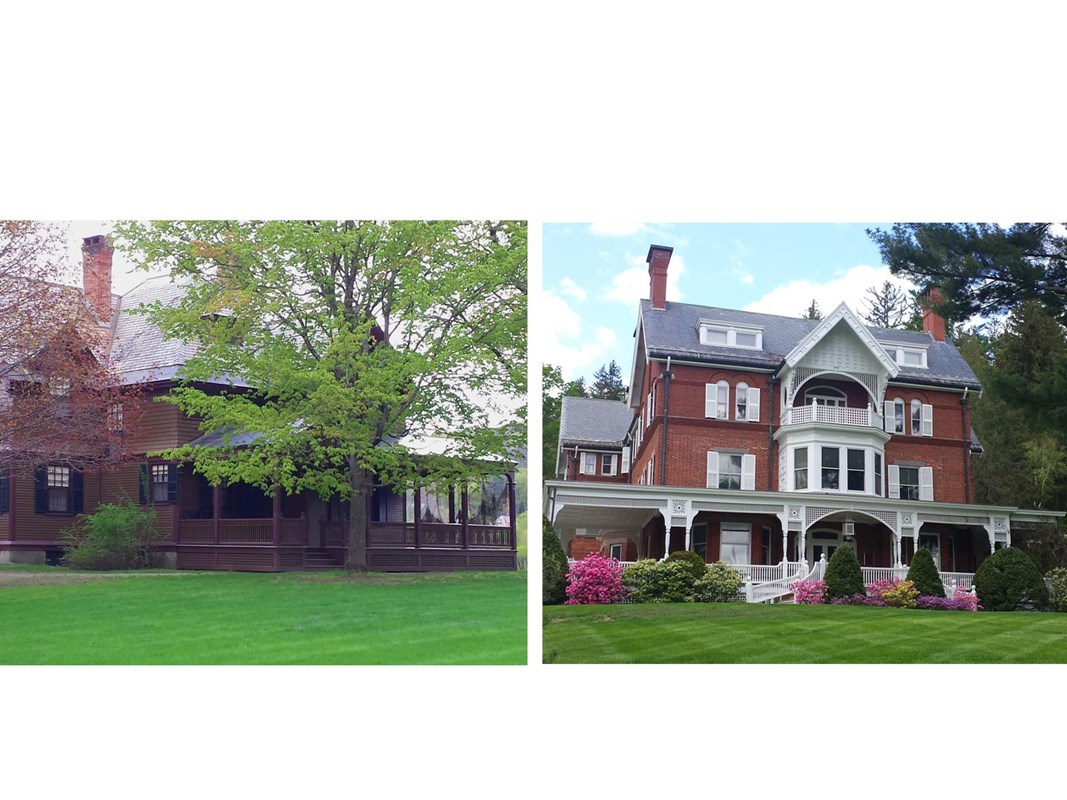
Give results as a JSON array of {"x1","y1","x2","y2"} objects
[{"x1": 538, "y1": 222, "x2": 1067, "y2": 663}]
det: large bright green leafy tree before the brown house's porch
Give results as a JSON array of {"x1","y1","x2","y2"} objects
[{"x1": 115, "y1": 221, "x2": 527, "y2": 570}]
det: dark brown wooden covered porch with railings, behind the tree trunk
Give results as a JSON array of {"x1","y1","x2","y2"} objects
[{"x1": 173, "y1": 466, "x2": 517, "y2": 572}]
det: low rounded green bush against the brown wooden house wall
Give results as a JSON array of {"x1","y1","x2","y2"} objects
[{"x1": 63, "y1": 499, "x2": 159, "y2": 570}]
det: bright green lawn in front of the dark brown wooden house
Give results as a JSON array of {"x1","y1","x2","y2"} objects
[{"x1": 0, "y1": 569, "x2": 526, "y2": 665}]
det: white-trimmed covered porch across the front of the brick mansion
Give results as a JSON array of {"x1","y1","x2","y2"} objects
[{"x1": 545, "y1": 482, "x2": 1058, "y2": 599}]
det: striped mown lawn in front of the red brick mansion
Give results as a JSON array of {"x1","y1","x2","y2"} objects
[{"x1": 544, "y1": 603, "x2": 1067, "y2": 663}]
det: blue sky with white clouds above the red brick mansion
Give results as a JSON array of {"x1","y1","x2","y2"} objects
[{"x1": 542, "y1": 223, "x2": 912, "y2": 383}]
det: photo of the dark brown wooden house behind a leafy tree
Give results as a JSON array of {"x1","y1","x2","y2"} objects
[{"x1": 0, "y1": 220, "x2": 528, "y2": 665}]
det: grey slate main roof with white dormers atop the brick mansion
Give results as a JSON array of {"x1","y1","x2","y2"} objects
[{"x1": 640, "y1": 300, "x2": 981, "y2": 389}]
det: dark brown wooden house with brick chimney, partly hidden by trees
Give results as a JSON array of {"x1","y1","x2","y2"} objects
[{"x1": 0, "y1": 237, "x2": 516, "y2": 572}]
